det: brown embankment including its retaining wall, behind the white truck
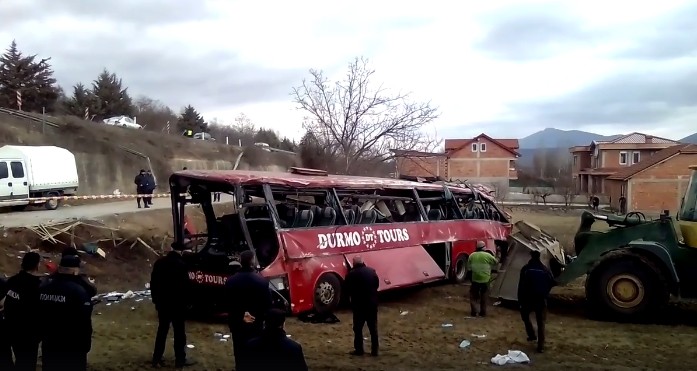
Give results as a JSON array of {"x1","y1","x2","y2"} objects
[{"x1": 0, "y1": 110, "x2": 296, "y2": 194}]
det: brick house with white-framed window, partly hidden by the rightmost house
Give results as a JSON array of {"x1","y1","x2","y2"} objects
[{"x1": 569, "y1": 133, "x2": 680, "y2": 198}]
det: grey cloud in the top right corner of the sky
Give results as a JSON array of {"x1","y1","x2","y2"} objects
[{"x1": 615, "y1": 2, "x2": 697, "y2": 60}]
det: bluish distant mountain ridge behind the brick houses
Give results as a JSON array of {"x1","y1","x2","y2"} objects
[{"x1": 518, "y1": 128, "x2": 697, "y2": 167}]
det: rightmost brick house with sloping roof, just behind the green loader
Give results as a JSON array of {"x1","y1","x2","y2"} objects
[{"x1": 605, "y1": 144, "x2": 697, "y2": 215}]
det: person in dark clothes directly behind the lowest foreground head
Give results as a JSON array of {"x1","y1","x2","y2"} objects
[{"x1": 225, "y1": 250, "x2": 272, "y2": 370}]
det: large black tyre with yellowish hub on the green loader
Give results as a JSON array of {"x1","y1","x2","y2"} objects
[{"x1": 586, "y1": 257, "x2": 669, "y2": 321}]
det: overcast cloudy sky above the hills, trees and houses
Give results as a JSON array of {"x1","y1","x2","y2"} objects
[{"x1": 0, "y1": 0, "x2": 697, "y2": 139}]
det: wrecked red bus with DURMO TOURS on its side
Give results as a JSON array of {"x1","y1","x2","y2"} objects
[{"x1": 169, "y1": 168, "x2": 512, "y2": 314}]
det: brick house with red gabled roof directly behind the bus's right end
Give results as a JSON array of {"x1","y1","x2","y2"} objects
[{"x1": 393, "y1": 134, "x2": 520, "y2": 186}]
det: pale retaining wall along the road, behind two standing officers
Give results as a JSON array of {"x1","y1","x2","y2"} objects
[{"x1": 75, "y1": 153, "x2": 286, "y2": 195}]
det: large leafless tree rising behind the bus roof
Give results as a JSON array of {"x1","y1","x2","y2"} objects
[{"x1": 292, "y1": 58, "x2": 438, "y2": 174}]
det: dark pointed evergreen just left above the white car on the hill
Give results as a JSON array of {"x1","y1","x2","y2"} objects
[{"x1": 91, "y1": 69, "x2": 135, "y2": 120}]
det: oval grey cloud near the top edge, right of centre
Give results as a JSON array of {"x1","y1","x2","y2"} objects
[{"x1": 475, "y1": 4, "x2": 599, "y2": 61}]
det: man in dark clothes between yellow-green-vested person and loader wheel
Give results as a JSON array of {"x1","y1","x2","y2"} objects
[{"x1": 518, "y1": 250, "x2": 554, "y2": 353}]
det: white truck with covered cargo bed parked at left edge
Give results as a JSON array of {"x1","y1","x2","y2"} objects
[{"x1": 0, "y1": 145, "x2": 79, "y2": 211}]
